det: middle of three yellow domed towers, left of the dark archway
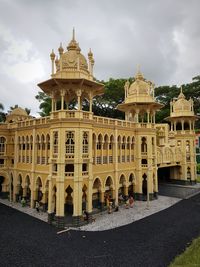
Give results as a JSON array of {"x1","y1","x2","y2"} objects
[{"x1": 118, "y1": 71, "x2": 162, "y2": 199}]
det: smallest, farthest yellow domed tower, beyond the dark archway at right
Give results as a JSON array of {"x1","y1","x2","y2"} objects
[{"x1": 166, "y1": 87, "x2": 197, "y2": 184}]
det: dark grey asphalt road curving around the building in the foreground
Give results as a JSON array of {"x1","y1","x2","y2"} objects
[{"x1": 0, "y1": 194, "x2": 200, "y2": 267}]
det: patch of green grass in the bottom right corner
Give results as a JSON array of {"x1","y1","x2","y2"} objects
[{"x1": 169, "y1": 237, "x2": 200, "y2": 267}]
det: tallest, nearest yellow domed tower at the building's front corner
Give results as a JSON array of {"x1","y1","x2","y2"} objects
[{"x1": 38, "y1": 30, "x2": 104, "y2": 227}]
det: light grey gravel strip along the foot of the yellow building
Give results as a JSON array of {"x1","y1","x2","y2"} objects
[{"x1": 0, "y1": 196, "x2": 181, "y2": 231}]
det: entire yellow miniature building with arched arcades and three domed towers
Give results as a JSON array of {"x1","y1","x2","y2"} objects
[{"x1": 0, "y1": 32, "x2": 196, "y2": 227}]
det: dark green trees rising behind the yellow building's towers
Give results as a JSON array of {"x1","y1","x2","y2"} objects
[{"x1": 36, "y1": 75, "x2": 200, "y2": 128}]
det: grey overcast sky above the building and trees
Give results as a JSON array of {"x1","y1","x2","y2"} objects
[{"x1": 0, "y1": 0, "x2": 200, "y2": 115}]
